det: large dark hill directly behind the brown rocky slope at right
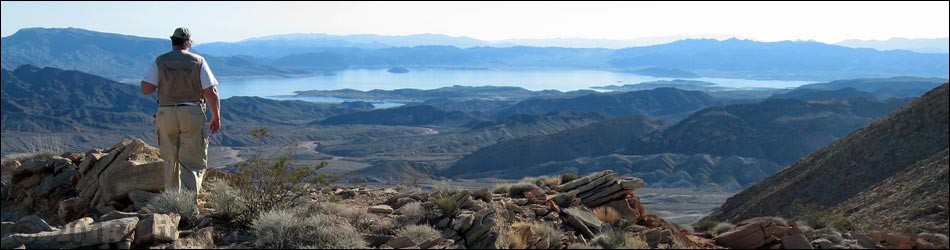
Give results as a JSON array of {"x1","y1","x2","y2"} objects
[{"x1": 644, "y1": 98, "x2": 909, "y2": 165}]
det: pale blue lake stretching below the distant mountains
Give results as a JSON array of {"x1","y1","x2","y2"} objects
[{"x1": 218, "y1": 68, "x2": 813, "y2": 104}]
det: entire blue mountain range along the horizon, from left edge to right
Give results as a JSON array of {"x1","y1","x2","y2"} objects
[{"x1": 0, "y1": 28, "x2": 950, "y2": 82}]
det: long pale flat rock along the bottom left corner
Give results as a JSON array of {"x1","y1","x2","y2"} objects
[{"x1": 12, "y1": 217, "x2": 139, "y2": 248}]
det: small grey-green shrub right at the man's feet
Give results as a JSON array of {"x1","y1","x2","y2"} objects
[{"x1": 145, "y1": 190, "x2": 198, "y2": 226}]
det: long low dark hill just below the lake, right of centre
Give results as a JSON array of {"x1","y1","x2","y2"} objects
[{"x1": 495, "y1": 88, "x2": 716, "y2": 120}]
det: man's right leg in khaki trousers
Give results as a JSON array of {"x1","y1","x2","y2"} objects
[{"x1": 178, "y1": 104, "x2": 208, "y2": 194}]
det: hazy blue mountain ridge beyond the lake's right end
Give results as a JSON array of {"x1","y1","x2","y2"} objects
[{"x1": 610, "y1": 39, "x2": 950, "y2": 80}]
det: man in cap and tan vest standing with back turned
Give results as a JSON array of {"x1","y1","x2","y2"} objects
[{"x1": 142, "y1": 27, "x2": 221, "y2": 194}]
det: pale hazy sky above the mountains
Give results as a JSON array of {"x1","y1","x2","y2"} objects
[{"x1": 0, "y1": 1, "x2": 950, "y2": 43}]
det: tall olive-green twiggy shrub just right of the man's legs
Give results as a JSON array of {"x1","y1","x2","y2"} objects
[{"x1": 231, "y1": 128, "x2": 340, "y2": 226}]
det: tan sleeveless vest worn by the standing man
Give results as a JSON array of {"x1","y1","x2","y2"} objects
[{"x1": 155, "y1": 50, "x2": 205, "y2": 105}]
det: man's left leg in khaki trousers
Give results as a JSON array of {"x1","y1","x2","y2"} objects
[{"x1": 155, "y1": 107, "x2": 181, "y2": 192}]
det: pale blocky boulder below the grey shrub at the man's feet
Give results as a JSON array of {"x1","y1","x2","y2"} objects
[{"x1": 133, "y1": 214, "x2": 181, "y2": 246}]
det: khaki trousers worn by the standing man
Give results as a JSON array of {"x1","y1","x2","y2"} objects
[{"x1": 155, "y1": 106, "x2": 208, "y2": 194}]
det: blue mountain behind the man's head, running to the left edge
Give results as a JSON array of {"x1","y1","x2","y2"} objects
[{"x1": 0, "y1": 28, "x2": 306, "y2": 83}]
